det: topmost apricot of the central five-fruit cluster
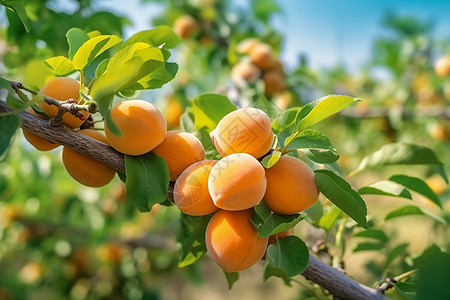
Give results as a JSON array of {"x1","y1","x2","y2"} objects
[{"x1": 214, "y1": 107, "x2": 273, "y2": 158}]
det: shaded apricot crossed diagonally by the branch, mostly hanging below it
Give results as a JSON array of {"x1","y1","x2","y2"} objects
[{"x1": 62, "y1": 129, "x2": 116, "y2": 187}]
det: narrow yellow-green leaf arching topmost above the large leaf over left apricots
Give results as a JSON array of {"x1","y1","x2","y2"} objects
[{"x1": 123, "y1": 26, "x2": 182, "y2": 49}]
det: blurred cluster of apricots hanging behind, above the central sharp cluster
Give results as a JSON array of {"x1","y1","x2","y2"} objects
[{"x1": 231, "y1": 38, "x2": 286, "y2": 103}]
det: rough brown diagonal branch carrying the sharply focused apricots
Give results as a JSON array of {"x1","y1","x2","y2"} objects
[{"x1": 0, "y1": 100, "x2": 387, "y2": 300}]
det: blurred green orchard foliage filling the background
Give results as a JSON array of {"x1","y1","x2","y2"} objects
[{"x1": 0, "y1": 0, "x2": 450, "y2": 300}]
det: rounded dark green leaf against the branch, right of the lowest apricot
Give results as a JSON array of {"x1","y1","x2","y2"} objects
[{"x1": 263, "y1": 236, "x2": 309, "y2": 281}]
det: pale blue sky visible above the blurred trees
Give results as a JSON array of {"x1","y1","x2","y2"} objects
[{"x1": 89, "y1": 0, "x2": 450, "y2": 70}]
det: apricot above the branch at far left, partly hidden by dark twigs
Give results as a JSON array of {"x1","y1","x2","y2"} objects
[{"x1": 39, "y1": 77, "x2": 90, "y2": 128}]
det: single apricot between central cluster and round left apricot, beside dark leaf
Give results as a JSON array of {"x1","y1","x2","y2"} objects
[{"x1": 153, "y1": 130, "x2": 205, "y2": 181}]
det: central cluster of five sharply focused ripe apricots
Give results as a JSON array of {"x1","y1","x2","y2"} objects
[{"x1": 173, "y1": 108, "x2": 319, "y2": 272}]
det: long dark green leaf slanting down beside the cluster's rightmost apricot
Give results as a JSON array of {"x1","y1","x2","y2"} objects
[{"x1": 315, "y1": 170, "x2": 367, "y2": 229}]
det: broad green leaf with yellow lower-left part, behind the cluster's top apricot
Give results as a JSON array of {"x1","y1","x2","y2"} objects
[{"x1": 192, "y1": 94, "x2": 236, "y2": 131}]
